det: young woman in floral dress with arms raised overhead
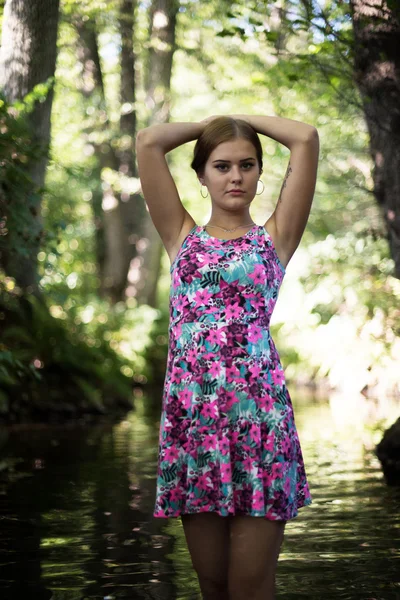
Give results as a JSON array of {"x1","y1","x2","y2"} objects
[{"x1": 136, "y1": 115, "x2": 319, "y2": 600}]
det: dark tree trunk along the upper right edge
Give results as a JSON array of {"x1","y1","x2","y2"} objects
[{"x1": 350, "y1": 0, "x2": 400, "y2": 279}]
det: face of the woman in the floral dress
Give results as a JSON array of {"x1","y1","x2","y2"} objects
[{"x1": 199, "y1": 138, "x2": 260, "y2": 210}]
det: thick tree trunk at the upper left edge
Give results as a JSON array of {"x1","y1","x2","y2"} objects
[{"x1": 0, "y1": 0, "x2": 59, "y2": 294}]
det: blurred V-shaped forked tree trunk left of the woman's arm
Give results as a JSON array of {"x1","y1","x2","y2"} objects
[{"x1": 73, "y1": 0, "x2": 146, "y2": 302}]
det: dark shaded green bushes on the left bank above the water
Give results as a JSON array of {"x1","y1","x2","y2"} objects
[{"x1": 0, "y1": 276, "x2": 132, "y2": 420}]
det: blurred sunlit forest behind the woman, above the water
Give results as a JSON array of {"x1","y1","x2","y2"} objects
[{"x1": 0, "y1": 0, "x2": 400, "y2": 421}]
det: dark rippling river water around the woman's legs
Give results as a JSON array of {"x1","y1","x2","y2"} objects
[{"x1": 0, "y1": 389, "x2": 400, "y2": 600}]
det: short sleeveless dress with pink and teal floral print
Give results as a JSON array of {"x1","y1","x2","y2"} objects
[{"x1": 153, "y1": 225, "x2": 312, "y2": 521}]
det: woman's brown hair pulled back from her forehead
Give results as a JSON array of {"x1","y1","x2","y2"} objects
[{"x1": 190, "y1": 117, "x2": 263, "y2": 175}]
